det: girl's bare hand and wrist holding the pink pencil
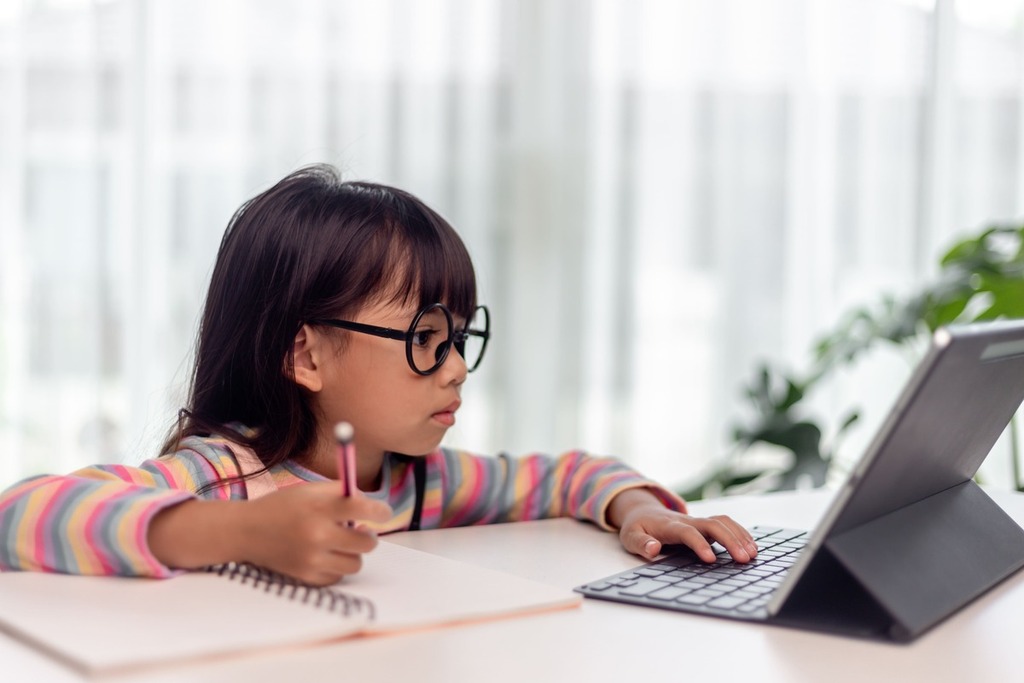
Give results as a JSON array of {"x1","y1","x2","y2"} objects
[{"x1": 147, "y1": 481, "x2": 391, "y2": 586}]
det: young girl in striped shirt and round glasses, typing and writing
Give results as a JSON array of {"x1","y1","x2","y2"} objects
[{"x1": 0, "y1": 166, "x2": 757, "y2": 585}]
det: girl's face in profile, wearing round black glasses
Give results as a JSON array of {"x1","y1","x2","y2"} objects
[{"x1": 313, "y1": 296, "x2": 466, "y2": 473}]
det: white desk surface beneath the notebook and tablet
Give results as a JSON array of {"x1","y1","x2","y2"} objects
[{"x1": 0, "y1": 492, "x2": 1024, "y2": 683}]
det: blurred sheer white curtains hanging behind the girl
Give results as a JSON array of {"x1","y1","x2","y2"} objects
[{"x1": 0, "y1": 0, "x2": 1024, "y2": 493}]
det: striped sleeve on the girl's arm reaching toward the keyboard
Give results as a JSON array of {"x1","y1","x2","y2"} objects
[{"x1": 403, "y1": 450, "x2": 686, "y2": 529}]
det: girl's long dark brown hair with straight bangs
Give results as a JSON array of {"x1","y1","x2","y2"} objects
[{"x1": 164, "y1": 165, "x2": 476, "y2": 475}]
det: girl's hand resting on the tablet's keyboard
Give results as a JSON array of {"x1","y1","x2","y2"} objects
[{"x1": 608, "y1": 488, "x2": 758, "y2": 562}]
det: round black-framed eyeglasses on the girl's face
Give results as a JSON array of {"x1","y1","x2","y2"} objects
[{"x1": 309, "y1": 303, "x2": 490, "y2": 375}]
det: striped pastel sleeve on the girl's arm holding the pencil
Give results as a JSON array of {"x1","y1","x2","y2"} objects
[{"x1": 0, "y1": 443, "x2": 245, "y2": 577}]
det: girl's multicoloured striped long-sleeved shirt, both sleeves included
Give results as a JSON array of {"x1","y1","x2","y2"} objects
[{"x1": 0, "y1": 436, "x2": 685, "y2": 578}]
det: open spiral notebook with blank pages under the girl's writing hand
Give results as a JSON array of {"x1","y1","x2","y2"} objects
[{"x1": 0, "y1": 541, "x2": 581, "y2": 673}]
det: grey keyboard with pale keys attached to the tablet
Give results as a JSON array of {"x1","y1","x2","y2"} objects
[{"x1": 574, "y1": 526, "x2": 808, "y2": 620}]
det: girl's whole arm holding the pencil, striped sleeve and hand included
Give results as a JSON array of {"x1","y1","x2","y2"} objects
[{"x1": 0, "y1": 444, "x2": 389, "y2": 583}]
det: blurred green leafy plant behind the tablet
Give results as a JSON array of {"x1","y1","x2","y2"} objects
[{"x1": 682, "y1": 225, "x2": 1024, "y2": 500}]
